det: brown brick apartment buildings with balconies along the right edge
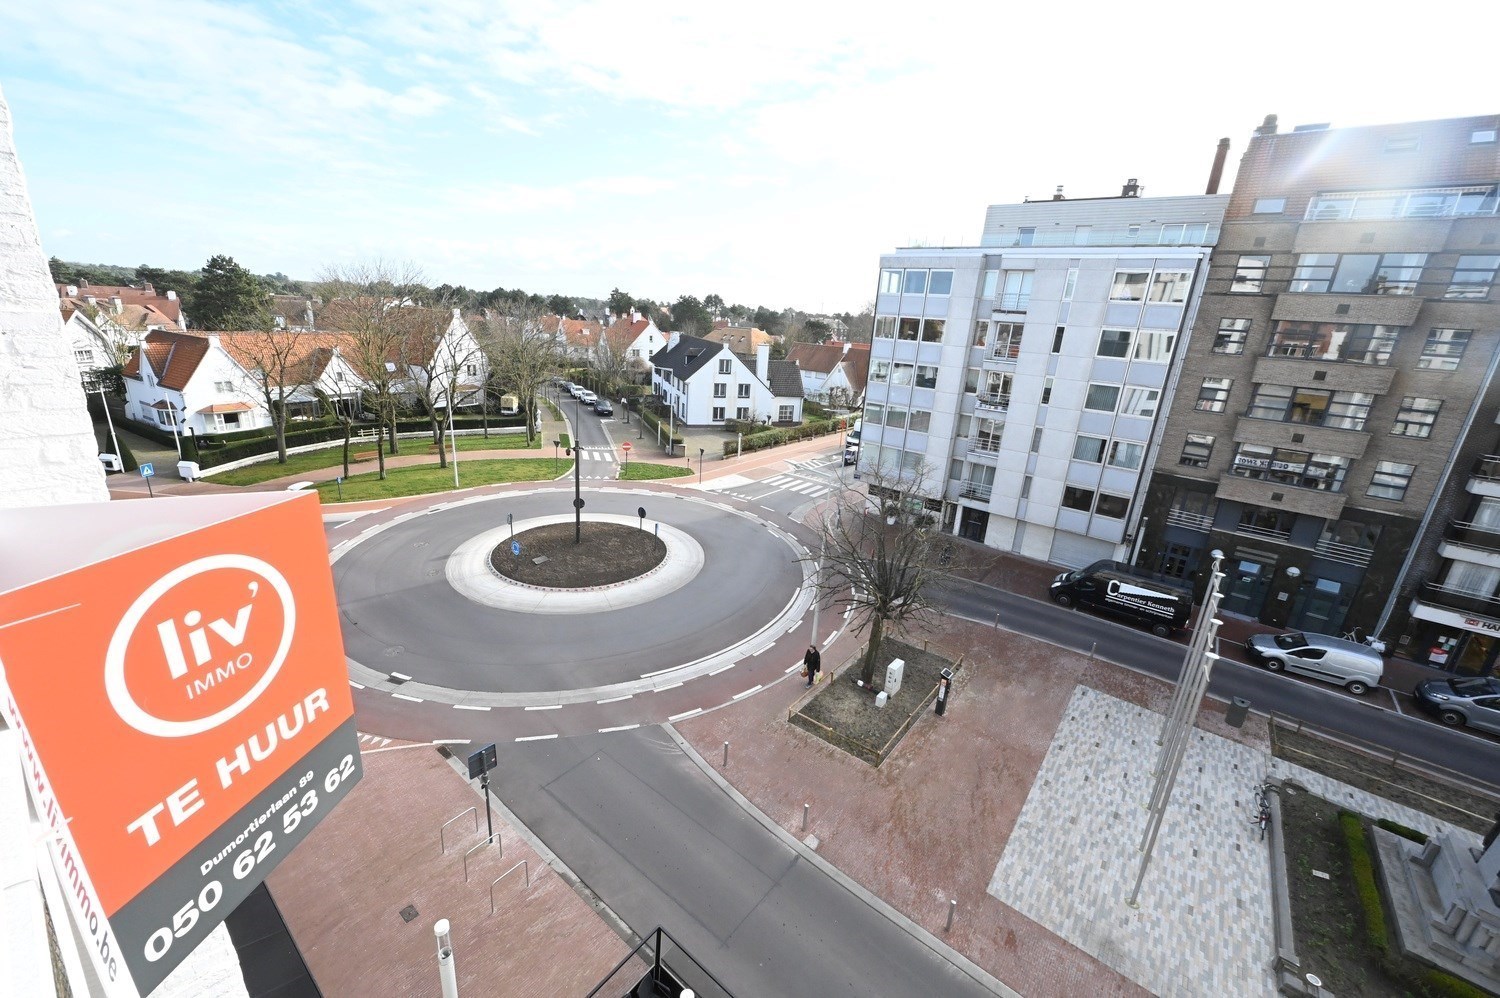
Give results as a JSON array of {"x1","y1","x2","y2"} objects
[{"x1": 1137, "y1": 116, "x2": 1500, "y2": 669}]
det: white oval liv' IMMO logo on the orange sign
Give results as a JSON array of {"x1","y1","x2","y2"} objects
[{"x1": 105, "y1": 554, "x2": 297, "y2": 738}]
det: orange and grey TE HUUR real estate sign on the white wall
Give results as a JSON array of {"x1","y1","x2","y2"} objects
[{"x1": 0, "y1": 494, "x2": 360, "y2": 995}]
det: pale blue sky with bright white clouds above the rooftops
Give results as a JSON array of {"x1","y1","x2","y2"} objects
[{"x1": 0, "y1": 0, "x2": 1500, "y2": 312}]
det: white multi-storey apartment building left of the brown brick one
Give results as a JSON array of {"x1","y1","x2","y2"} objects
[{"x1": 860, "y1": 180, "x2": 1229, "y2": 566}]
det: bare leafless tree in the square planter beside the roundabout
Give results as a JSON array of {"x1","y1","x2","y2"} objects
[{"x1": 807, "y1": 470, "x2": 953, "y2": 686}]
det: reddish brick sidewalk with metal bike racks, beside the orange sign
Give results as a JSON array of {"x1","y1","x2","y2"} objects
[{"x1": 267, "y1": 740, "x2": 629, "y2": 998}]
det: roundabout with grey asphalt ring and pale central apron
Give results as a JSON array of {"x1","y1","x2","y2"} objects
[{"x1": 333, "y1": 488, "x2": 834, "y2": 734}]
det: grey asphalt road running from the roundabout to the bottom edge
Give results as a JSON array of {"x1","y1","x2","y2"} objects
[{"x1": 492, "y1": 728, "x2": 993, "y2": 996}]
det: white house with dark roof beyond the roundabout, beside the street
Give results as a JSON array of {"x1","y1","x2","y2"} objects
[{"x1": 651, "y1": 333, "x2": 803, "y2": 426}]
